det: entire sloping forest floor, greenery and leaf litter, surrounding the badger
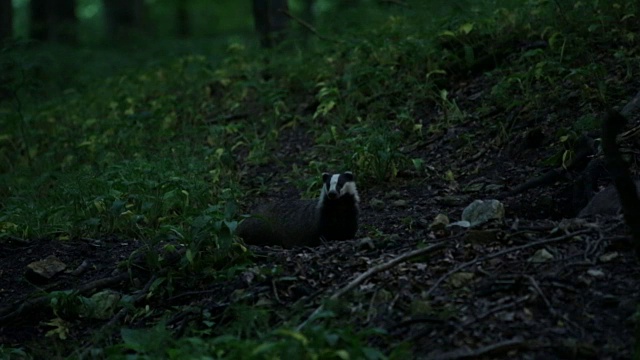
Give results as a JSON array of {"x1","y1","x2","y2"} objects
[{"x1": 0, "y1": 1, "x2": 640, "y2": 359}]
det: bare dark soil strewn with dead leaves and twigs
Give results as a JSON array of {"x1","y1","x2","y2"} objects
[{"x1": 5, "y1": 67, "x2": 640, "y2": 359}]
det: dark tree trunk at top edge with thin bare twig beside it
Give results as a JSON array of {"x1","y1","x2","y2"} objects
[{"x1": 253, "y1": 0, "x2": 289, "y2": 47}]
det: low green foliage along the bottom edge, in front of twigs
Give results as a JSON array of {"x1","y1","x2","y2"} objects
[{"x1": 104, "y1": 325, "x2": 387, "y2": 360}]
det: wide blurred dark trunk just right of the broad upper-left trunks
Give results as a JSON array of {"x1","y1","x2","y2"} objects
[{"x1": 103, "y1": 0, "x2": 144, "y2": 40}]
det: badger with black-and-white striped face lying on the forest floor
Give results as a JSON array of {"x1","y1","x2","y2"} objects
[{"x1": 237, "y1": 171, "x2": 360, "y2": 248}]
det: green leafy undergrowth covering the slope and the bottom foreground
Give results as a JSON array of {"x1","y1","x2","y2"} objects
[{"x1": 0, "y1": 0, "x2": 640, "y2": 359}]
